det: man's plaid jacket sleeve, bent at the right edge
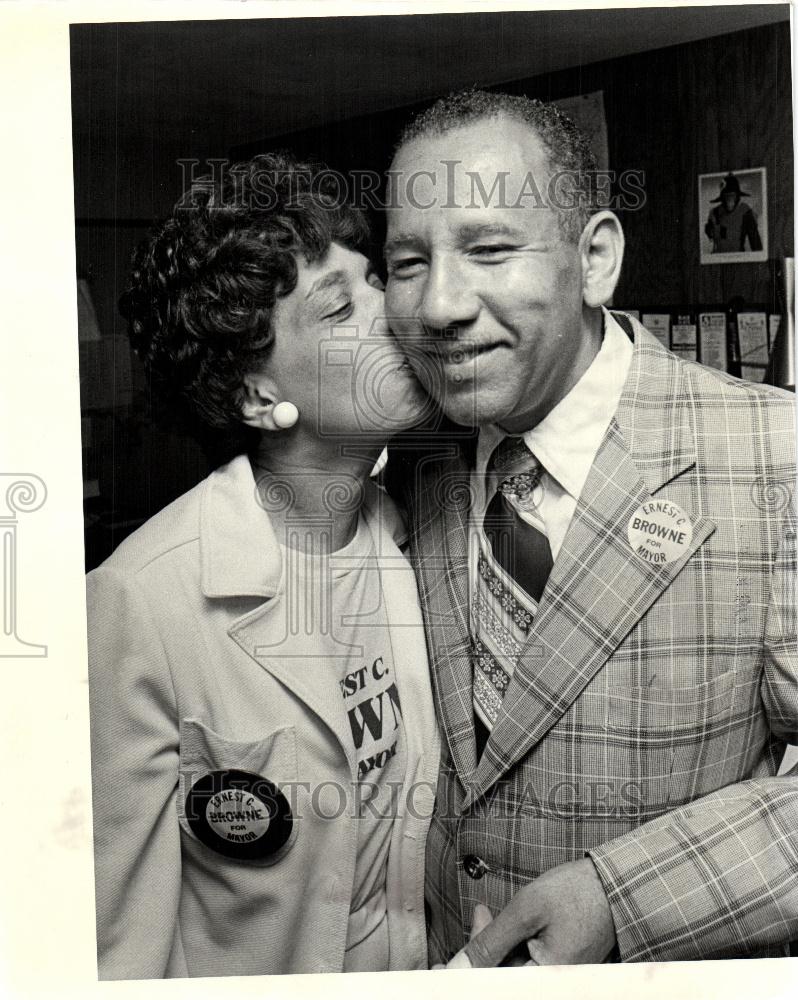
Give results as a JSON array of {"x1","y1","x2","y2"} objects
[{"x1": 589, "y1": 492, "x2": 798, "y2": 961}]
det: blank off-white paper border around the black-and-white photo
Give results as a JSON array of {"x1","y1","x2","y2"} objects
[{"x1": 0, "y1": 0, "x2": 798, "y2": 1000}]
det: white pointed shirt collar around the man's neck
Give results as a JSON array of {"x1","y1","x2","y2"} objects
[{"x1": 476, "y1": 309, "x2": 633, "y2": 500}]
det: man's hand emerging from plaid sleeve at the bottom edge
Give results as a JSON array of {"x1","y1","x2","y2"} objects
[{"x1": 447, "y1": 858, "x2": 615, "y2": 969}]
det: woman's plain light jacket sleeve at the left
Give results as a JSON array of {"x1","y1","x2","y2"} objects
[{"x1": 87, "y1": 568, "x2": 182, "y2": 979}]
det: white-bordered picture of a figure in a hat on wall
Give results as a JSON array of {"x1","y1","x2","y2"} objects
[{"x1": 698, "y1": 167, "x2": 768, "y2": 264}]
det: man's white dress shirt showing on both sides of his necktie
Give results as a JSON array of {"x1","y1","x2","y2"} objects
[{"x1": 469, "y1": 309, "x2": 633, "y2": 580}]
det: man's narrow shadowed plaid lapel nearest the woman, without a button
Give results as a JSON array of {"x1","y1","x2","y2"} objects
[{"x1": 409, "y1": 444, "x2": 476, "y2": 780}]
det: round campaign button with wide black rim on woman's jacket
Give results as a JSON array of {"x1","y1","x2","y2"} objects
[{"x1": 186, "y1": 770, "x2": 294, "y2": 861}]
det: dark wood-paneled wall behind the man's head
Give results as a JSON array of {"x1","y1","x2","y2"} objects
[{"x1": 234, "y1": 22, "x2": 793, "y2": 307}]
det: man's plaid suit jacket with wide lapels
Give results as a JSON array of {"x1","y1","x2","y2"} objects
[{"x1": 393, "y1": 317, "x2": 798, "y2": 962}]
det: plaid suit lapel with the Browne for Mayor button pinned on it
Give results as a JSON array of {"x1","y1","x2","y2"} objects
[{"x1": 467, "y1": 328, "x2": 715, "y2": 802}]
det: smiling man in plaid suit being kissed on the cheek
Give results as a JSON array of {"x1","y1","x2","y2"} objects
[{"x1": 386, "y1": 92, "x2": 798, "y2": 965}]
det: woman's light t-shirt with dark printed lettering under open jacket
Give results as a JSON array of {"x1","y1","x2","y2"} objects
[{"x1": 281, "y1": 517, "x2": 406, "y2": 971}]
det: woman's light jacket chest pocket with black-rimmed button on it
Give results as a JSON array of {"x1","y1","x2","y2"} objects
[{"x1": 177, "y1": 719, "x2": 298, "y2": 865}]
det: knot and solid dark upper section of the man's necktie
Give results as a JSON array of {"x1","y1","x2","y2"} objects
[{"x1": 484, "y1": 437, "x2": 552, "y2": 602}]
